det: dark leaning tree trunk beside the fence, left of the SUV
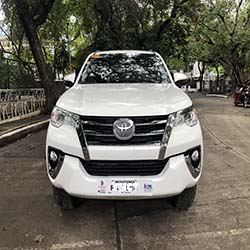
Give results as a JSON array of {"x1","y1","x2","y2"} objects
[{"x1": 3, "y1": 0, "x2": 62, "y2": 111}]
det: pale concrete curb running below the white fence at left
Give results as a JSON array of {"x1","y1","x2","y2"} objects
[{"x1": 0, "y1": 119, "x2": 49, "y2": 147}]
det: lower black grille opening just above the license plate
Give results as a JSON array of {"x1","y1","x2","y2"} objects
[{"x1": 81, "y1": 159, "x2": 168, "y2": 176}]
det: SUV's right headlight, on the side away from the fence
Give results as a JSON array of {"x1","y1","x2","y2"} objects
[{"x1": 175, "y1": 106, "x2": 198, "y2": 127}]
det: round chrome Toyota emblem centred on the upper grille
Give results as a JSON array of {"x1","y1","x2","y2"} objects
[{"x1": 113, "y1": 118, "x2": 135, "y2": 141}]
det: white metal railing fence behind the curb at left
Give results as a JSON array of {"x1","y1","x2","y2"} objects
[{"x1": 0, "y1": 89, "x2": 45, "y2": 124}]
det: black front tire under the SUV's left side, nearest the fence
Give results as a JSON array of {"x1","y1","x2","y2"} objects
[{"x1": 53, "y1": 186, "x2": 80, "y2": 210}]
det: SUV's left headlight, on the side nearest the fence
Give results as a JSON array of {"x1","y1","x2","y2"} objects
[{"x1": 50, "y1": 107, "x2": 80, "y2": 128}]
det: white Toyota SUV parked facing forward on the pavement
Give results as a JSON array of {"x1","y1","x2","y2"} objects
[{"x1": 46, "y1": 51, "x2": 203, "y2": 209}]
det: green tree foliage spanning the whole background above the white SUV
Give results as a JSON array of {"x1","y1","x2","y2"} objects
[{"x1": 3, "y1": 0, "x2": 250, "y2": 88}]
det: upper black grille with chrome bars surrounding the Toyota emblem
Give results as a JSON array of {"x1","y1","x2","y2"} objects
[{"x1": 81, "y1": 115, "x2": 168, "y2": 145}]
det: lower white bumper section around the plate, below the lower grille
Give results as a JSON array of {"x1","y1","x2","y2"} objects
[{"x1": 50, "y1": 152, "x2": 199, "y2": 199}]
